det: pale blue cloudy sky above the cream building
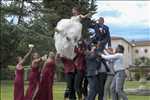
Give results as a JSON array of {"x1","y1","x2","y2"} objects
[{"x1": 93, "y1": 1, "x2": 150, "y2": 40}]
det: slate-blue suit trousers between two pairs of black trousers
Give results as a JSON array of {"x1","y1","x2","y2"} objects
[{"x1": 86, "y1": 75, "x2": 98, "y2": 100}]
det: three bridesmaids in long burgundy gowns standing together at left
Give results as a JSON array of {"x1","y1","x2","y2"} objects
[{"x1": 14, "y1": 48, "x2": 55, "y2": 100}]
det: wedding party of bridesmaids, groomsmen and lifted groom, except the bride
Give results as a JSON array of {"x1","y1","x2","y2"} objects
[{"x1": 14, "y1": 6, "x2": 128, "y2": 100}]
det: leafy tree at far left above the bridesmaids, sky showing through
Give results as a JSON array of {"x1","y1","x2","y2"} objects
[{"x1": 0, "y1": 0, "x2": 53, "y2": 68}]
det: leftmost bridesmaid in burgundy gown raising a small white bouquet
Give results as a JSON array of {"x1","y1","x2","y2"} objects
[{"x1": 14, "y1": 48, "x2": 32, "y2": 100}]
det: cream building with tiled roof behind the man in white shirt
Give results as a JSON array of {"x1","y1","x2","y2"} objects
[{"x1": 111, "y1": 37, "x2": 150, "y2": 67}]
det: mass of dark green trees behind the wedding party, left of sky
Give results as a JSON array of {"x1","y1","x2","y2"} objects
[{"x1": 0, "y1": 0, "x2": 96, "y2": 67}]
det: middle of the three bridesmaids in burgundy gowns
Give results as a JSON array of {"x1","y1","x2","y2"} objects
[{"x1": 25, "y1": 53, "x2": 41, "y2": 100}]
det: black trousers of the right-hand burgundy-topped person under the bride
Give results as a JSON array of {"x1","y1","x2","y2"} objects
[{"x1": 74, "y1": 70, "x2": 84, "y2": 98}]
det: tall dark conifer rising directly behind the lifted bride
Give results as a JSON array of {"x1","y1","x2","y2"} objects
[{"x1": 43, "y1": 0, "x2": 96, "y2": 38}]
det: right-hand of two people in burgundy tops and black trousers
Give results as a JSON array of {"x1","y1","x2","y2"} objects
[{"x1": 74, "y1": 40, "x2": 86, "y2": 100}]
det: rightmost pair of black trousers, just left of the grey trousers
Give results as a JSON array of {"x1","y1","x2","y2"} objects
[{"x1": 97, "y1": 73, "x2": 107, "y2": 100}]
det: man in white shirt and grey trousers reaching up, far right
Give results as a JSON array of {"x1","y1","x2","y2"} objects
[{"x1": 101, "y1": 45, "x2": 128, "y2": 100}]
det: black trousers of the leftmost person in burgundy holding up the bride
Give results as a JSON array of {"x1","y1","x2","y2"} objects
[{"x1": 64, "y1": 73, "x2": 76, "y2": 100}]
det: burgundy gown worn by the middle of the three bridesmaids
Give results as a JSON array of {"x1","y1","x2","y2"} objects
[{"x1": 25, "y1": 64, "x2": 40, "y2": 100}]
